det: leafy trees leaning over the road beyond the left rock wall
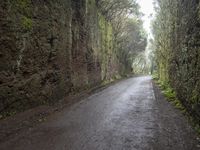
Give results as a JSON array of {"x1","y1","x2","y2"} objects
[{"x1": 97, "y1": 0, "x2": 147, "y2": 75}]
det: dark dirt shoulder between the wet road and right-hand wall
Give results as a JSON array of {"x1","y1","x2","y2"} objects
[{"x1": 153, "y1": 82, "x2": 200, "y2": 150}]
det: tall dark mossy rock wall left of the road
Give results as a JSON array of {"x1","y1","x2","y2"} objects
[{"x1": 0, "y1": 0, "x2": 119, "y2": 116}]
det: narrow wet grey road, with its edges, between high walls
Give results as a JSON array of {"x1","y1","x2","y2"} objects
[{"x1": 0, "y1": 76, "x2": 199, "y2": 150}]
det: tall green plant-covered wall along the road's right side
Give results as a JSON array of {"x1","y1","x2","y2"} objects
[{"x1": 151, "y1": 0, "x2": 200, "y2": 128}]
